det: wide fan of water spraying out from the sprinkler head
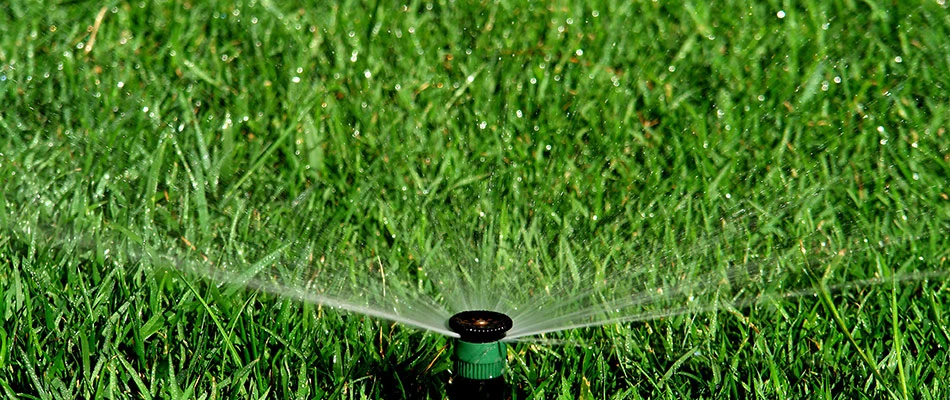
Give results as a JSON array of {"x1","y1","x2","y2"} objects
[{"x1": 151, "y1": 163, "x2": 945, "y2": 340}]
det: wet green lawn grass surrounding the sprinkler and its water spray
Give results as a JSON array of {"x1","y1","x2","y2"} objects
[{"x1": 0, "y1": 0, "x2": 950, "y2": 399}]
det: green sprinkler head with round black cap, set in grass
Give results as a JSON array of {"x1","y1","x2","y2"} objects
[{"x1": 449, "y1": 310, "x2": 512, "y2": 380}]
